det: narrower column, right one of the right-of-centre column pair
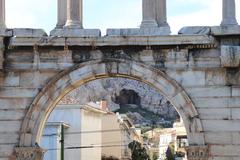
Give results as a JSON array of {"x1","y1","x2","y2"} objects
[{"x1": 156, "y1": 0, "x2": 169, "y2": 27}]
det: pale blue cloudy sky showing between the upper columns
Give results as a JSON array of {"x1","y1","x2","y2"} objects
[{"x1": 6, "y1": 0, "x2": 240, "y2": 34}]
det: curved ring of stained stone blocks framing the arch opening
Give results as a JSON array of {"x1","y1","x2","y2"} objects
[{"x1": 19, "y1": 59, "x2": 205, "y2": 147}]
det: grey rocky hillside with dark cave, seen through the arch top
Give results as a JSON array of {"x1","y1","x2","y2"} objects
[{"x1": 60, "y1": 78, "x2": 178, "y2": 127}]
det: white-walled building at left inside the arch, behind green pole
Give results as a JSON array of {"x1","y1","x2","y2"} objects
[{"x1": 41, "y1": 105, "x2": 107, "y2": 160}]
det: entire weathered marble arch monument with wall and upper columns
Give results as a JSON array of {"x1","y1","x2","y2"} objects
[{"x1": 0, "y1": 0, "x2": 240, "y2": 160}]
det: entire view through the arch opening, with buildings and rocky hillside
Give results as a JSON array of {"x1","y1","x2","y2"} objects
[{"x1": 40, "y1": 78, "x2": 188, "y2": 160}]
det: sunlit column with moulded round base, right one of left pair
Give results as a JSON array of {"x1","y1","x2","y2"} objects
[{"x1": 65, "y1": 0, "x2": 83, "y2": 29}]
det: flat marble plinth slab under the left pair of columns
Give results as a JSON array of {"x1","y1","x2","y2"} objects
[{"x1": 50, "y1": 27, "x2": 101, "y2": 38}]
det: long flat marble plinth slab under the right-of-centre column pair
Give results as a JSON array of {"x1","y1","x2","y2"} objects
[{"x1": 107, "y1": 27, "x2": 171, "y2": 36}]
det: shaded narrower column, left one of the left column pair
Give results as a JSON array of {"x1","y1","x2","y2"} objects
[{"x1": 56, "y1": 0, "x2": 67, "y2": 29}]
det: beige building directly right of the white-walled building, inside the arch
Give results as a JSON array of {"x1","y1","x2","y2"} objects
[{"x1": 102, "y1": 112, "x2": 142, "y2": 160}]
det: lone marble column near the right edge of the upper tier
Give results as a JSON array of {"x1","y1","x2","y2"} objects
[{"x1": 221, "y1": 0, "x2": 237, "y2": 26}]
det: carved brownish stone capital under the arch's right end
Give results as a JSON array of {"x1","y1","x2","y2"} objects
[{"x1": 186, "y1": 146, "x2": 209, "y2": 160}]
